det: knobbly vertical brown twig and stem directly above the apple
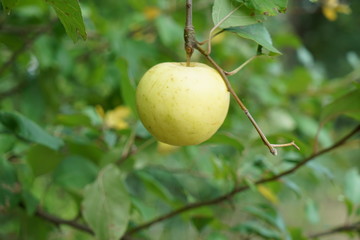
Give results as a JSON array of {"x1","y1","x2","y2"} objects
[{"x1": 184, "y1": 0, "x2": 197, "y2": 67}]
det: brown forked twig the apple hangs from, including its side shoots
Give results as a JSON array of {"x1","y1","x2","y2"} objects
[{"x1": 184, "y1": 0, "x2": 300, "y2": 155}]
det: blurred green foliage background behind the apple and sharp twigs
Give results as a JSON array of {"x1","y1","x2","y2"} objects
[{"x1": 0, "y1": 0, "x2": 360, "y2": 240}]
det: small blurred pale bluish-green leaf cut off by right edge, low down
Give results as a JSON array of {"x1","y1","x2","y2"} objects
[{"x1": 344, "y1": 168, "x2": 360, "y2": 205}]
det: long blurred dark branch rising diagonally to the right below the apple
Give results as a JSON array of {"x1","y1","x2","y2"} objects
[{"x1": 124, "y1": 125, "x2": 360, "y2": 236}]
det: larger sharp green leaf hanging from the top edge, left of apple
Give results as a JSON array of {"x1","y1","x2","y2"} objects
[{"x1": 45, "y1": 0, "x2": 87, "y2": 42}]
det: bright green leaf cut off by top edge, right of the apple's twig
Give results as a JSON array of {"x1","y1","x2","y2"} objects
[{"x1": 241, "y1": 0, "x2": 288, "y2": 16}]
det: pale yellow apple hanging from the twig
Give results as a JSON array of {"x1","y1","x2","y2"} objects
[{"x1": 136, "y1": 62, "x2": 230, "y2": 146}]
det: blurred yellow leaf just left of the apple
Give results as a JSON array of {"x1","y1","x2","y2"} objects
[{"x1": 105, "y1": 106, "x2": 130, "y2": 130}]
